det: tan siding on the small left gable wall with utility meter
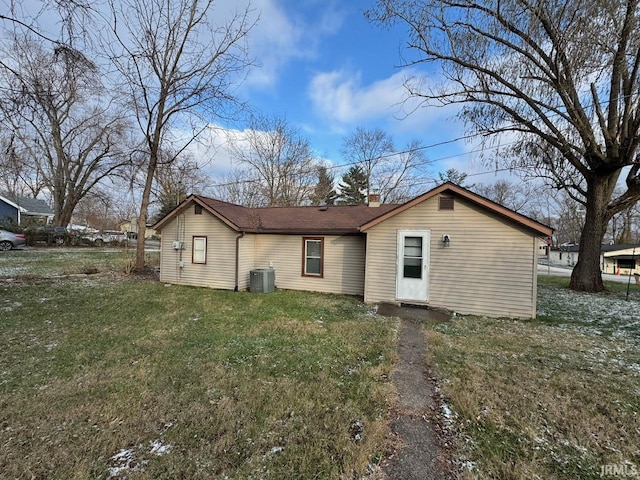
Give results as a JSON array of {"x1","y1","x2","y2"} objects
[{"x1": 160, "y1": 207, "x2": 236, "y2": 290}]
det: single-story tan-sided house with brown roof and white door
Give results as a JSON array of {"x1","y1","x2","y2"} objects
[{"x1": 155, "y1": 182, "x2": 553, "y2": 318}]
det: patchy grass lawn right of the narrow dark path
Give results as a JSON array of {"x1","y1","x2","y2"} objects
[{"x1": 426, "y1": 276, "x2": 640, "y2": 479}]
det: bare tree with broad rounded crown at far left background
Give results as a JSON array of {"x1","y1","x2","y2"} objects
[{"x1": 0, "y1": 37, "x2": 127, "y2": 225}]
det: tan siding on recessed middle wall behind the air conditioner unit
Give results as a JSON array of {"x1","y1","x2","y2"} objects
[{"x1": 255, "y1": 235, "x2": 365, "y2": 295}]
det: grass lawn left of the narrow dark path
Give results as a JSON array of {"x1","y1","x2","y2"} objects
[{"x1": 0, "y1": 250, "x2": 397, "y2": 479}]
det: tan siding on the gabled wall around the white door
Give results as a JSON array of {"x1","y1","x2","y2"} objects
[{"x1": 365, "y1": 196, "x2": 537, "y2": 318}]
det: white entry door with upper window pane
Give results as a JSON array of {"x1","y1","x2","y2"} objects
[{"x1": 396, "y1": 230, "x2": 430, "y2": 302}]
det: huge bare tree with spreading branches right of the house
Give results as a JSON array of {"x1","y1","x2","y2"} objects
[{"x1": 368, "y1": 0, "x2": 640, "y2": 291}]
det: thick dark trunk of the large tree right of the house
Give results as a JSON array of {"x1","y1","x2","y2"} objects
[{"x1": 569, "y1": 174, "x2": 618, "y2": 292}]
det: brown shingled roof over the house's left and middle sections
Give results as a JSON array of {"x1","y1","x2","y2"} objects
[{"x1": 155, "y1": 195, "x2": 397, "y2": 235}]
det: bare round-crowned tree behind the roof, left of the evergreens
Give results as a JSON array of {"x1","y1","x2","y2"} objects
[{"x1": 229, "y1": 116, "x2": 318, "y2": 207}]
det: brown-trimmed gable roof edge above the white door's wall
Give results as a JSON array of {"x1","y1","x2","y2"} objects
[{"x1": 360, "y1": 182, "x2": 553, "y2": 235}]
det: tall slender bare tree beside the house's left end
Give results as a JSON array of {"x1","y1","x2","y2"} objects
[{"x1": 111, "y1": 0, "x2": 253, "y2": 270}]
